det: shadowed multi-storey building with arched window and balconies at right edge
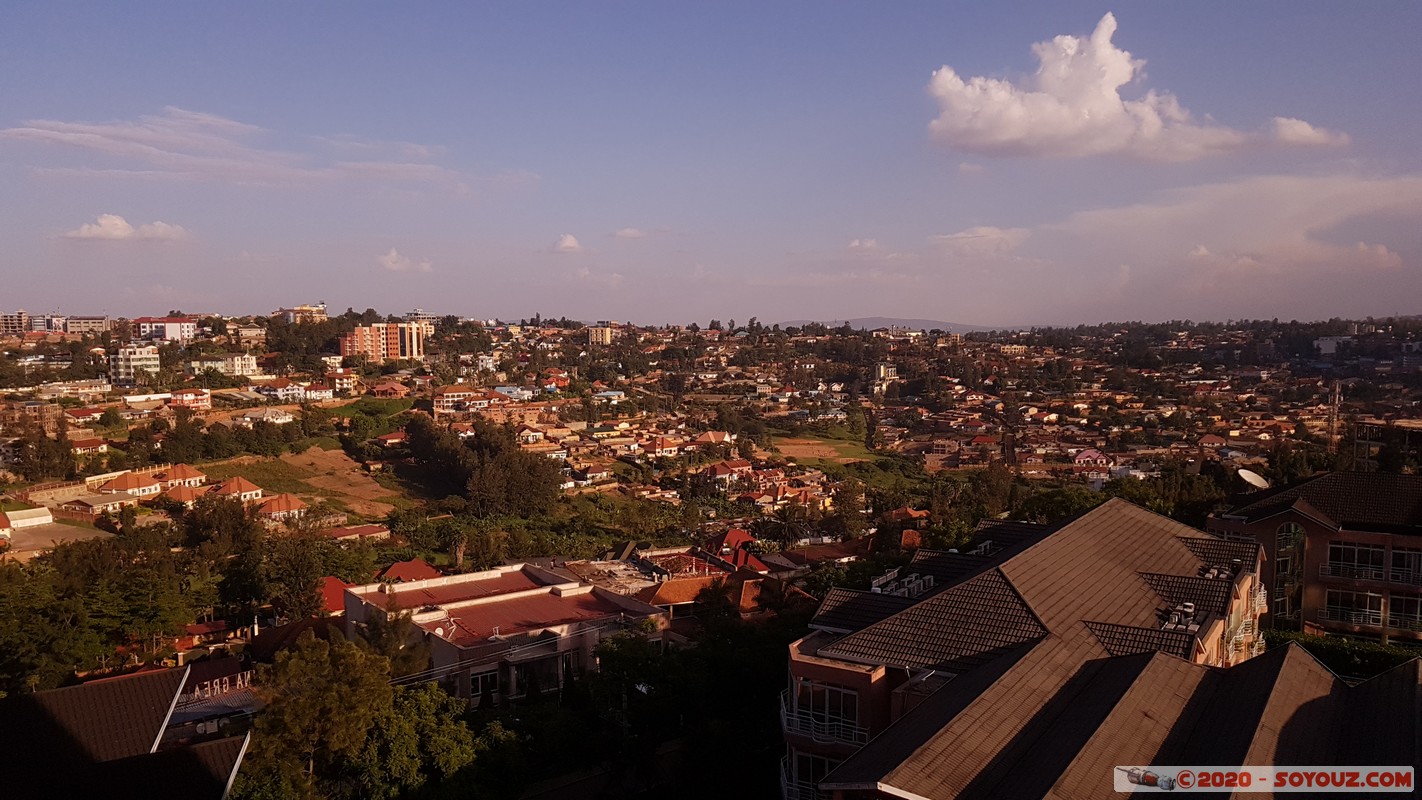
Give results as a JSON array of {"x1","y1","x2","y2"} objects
[{"x1": 1207, "y1": 472, "x2": 1422, "y2": 641}]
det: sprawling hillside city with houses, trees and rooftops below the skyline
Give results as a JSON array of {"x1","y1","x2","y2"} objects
[{"x1": 0, "y1": 303, "x2": 1422, "y2": 800}]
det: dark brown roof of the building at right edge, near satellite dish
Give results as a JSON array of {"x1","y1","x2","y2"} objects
[{"x1": 1229, "y1": 472, "x2": 1422, "y2": 533}]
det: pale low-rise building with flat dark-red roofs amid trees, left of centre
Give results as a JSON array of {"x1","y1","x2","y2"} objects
[{"x1": 346, "y1": 564, "x2": 668, "y2": 705}]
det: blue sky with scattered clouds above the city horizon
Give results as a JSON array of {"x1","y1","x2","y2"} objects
[{"x1": 0, "y1": 3, "x2": 1422, "y2": 325}]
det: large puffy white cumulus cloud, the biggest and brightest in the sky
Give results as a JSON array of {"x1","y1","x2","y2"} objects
[{"x1": 929, "y1": 13, "x2": 1348, "y2": 161}]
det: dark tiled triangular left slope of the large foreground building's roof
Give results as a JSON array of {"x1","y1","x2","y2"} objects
[{"x1": 819, "y1": 570, "x2": 1047, "y2": 674}]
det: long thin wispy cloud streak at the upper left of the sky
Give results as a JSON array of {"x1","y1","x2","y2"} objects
[{"x1": 0, "y1": 107, "x2": 466, "y2": 189}]
